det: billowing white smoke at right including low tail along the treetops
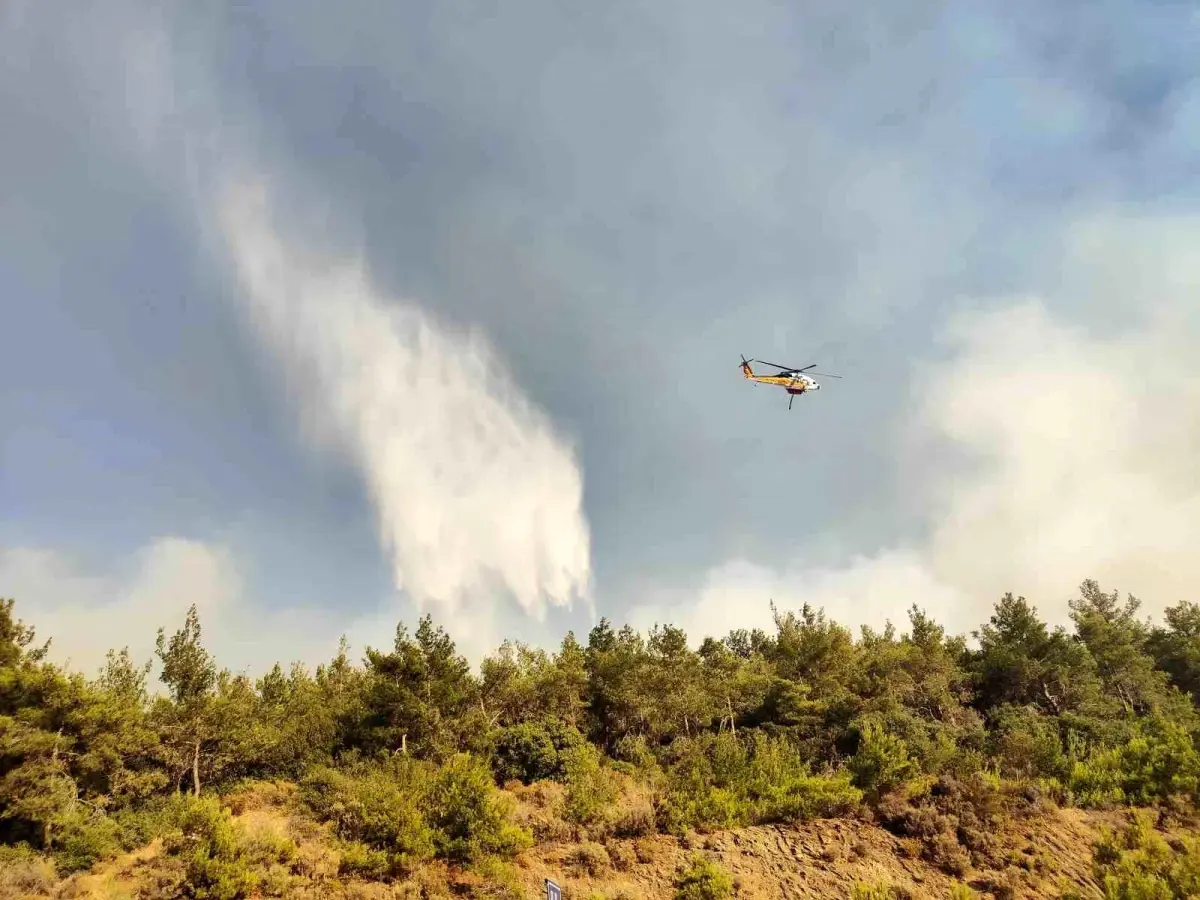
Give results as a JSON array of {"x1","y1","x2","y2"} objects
[{"x1": 635, "y1": 216, "x2": 1200, "y2": 640}]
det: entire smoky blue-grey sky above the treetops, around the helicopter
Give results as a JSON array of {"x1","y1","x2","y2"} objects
[{"x1": 0, "y1": 0, "x2": 1200, "y2": 672}]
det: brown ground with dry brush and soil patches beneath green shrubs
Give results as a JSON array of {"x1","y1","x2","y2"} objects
[{"x1": 9, "y1": 782, "x2": 1180, "y2": 900}]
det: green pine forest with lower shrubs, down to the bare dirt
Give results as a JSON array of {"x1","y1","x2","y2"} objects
[{"x1": 0, "y1": 581, "x2": 1200, "y2": 900}]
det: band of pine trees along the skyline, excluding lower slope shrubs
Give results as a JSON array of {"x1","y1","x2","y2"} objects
[{"x1": 0, "y1": 581, "x2": 1200, "y2": 892}]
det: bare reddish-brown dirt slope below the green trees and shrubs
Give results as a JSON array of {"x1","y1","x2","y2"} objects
[{"x1": 28, "y1": 803, "x2": 1122, "y2": 900}]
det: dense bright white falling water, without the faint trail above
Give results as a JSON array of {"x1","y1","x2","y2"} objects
[{"x1": 218, "y1": 182, "x2": 590, "y2": 625}]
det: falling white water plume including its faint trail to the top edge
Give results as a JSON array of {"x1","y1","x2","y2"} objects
[{"x1": 4, "y1": 2, "x2": 592, "y2": 652}]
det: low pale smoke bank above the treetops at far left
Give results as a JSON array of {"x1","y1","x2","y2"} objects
[{"x1": 0, "y1": 536, "x2": 549, "y2": 677}]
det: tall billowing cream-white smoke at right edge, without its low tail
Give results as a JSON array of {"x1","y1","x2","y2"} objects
[{"x1": 920, "y1": 214, "x2": 1200, "y2": 614}]
